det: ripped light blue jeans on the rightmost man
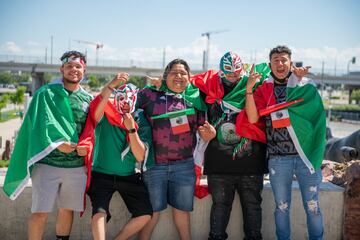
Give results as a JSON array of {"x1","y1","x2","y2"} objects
[{"x1": 269, "y1": 155, "x2": 324, "y2": 240}]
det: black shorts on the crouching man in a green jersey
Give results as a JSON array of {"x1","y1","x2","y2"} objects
[{"x1": 87, "y1": 172, "x2": 153, "y2": 221}]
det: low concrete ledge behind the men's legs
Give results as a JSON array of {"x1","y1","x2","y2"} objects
[{"x1": 0, "y1": 179, "x2": 344, "y2": 240}]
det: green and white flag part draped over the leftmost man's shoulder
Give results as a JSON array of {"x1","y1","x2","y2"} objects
[{"x1": 3, "y1": 82, "x2": 90, "y2": 200}]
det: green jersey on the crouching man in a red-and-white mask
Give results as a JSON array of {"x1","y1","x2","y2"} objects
[{"x1": 92, "y1": 109, "x2": 154, "y2": 176}]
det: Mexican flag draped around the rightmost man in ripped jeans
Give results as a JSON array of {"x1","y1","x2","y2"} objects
[{"x1": 237, "y1": 74, "x2": 326, "y2": 172}]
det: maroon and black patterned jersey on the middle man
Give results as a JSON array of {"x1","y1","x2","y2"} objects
[{"x1": 137, "y1": 88, "x2": 205, "y2": 163}]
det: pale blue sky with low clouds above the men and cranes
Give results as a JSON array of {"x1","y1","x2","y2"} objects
[{"x1": 0, "y1": 0, "x2": 360, "y2": 73}]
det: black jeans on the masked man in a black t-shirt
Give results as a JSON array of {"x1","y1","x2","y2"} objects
[{"x1": 208, "y1": 174, "x2": 263, "y2": 240}]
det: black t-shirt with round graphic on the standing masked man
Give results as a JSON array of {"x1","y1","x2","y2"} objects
[{"x1": 204, "y1": 81, "x2": 267, "y2": 174}]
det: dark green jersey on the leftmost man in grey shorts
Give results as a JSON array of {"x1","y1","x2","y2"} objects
[{"x1": 39, "y1": 85, "x2": 93, "y2": 168}]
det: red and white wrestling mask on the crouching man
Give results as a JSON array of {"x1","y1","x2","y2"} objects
[{"x1": 114, "y1": 83, "x2": 139, "y2": 114}]
